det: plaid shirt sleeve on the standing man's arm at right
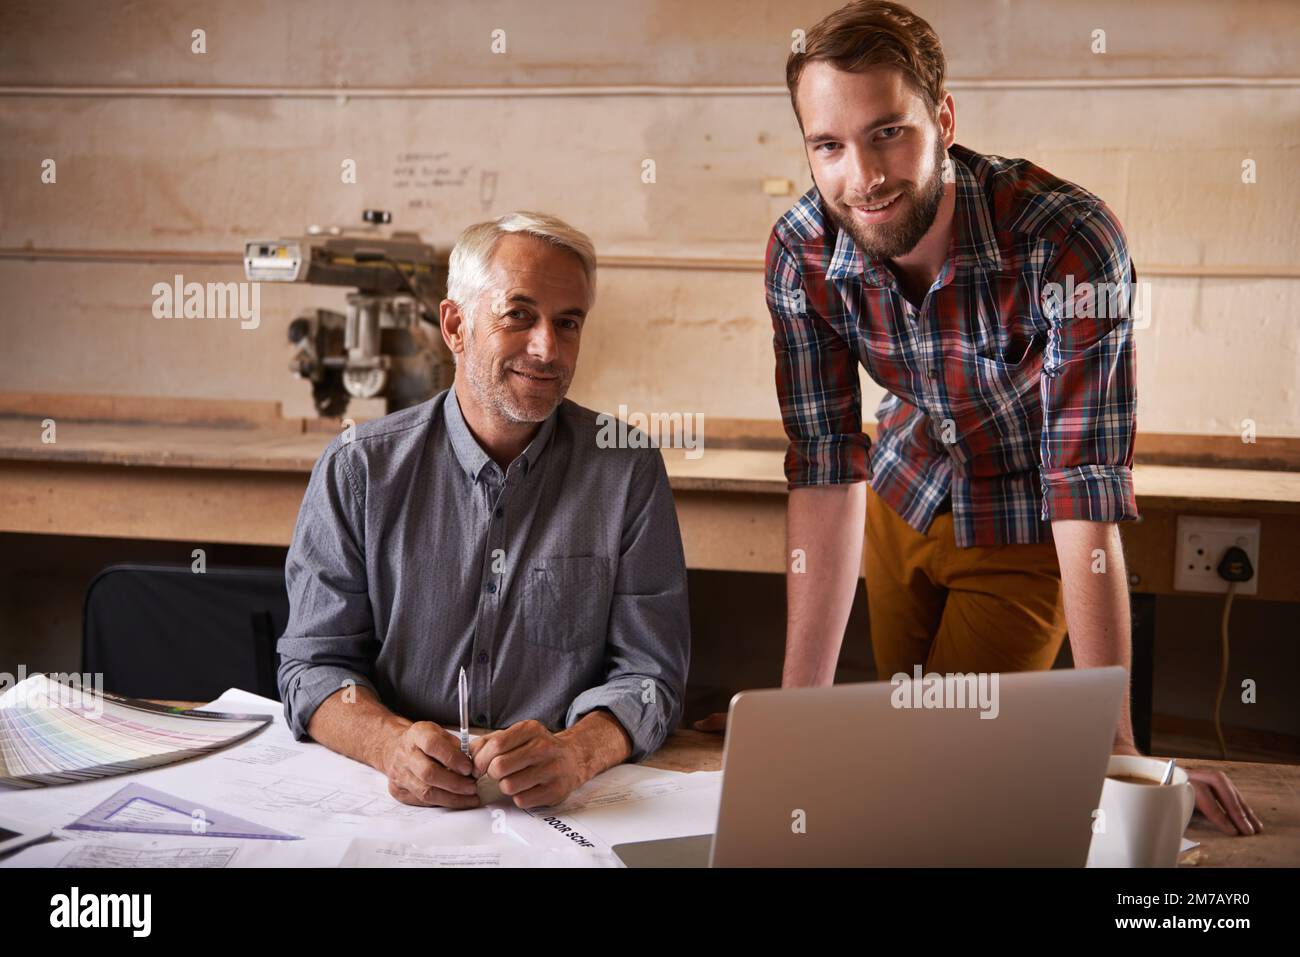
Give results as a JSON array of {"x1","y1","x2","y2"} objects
[{"x1": 1040, "y1": 203, "x2": 1138, "y2": 521}]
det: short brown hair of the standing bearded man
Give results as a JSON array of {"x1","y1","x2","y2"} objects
[{"x1": 785, "y1": 0, "x2": 948, "y2": 126}]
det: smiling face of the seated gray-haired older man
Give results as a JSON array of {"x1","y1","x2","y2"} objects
[{"x1": 449, "y1": 234, "x2": 592, "y2": 425}]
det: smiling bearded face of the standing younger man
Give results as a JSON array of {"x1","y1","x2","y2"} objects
[{"x1": 797, "y1": 61, "x2": 953, "y2": 259}]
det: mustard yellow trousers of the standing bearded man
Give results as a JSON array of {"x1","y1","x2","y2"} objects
[{"x1": 866, "y1": 488, "x2": 1065, "y2": 681}]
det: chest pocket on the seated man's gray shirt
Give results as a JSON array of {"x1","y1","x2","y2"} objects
[{"x1": 524, "y1": 555, "x2": 610, "y2": 651}]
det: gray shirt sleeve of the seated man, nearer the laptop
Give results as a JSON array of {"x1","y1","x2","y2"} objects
[{"x1": 566, "y1": 450, "x2": 690, "y2": 761}]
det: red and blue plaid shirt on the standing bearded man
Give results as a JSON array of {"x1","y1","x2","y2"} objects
[{"x1": 767, "y1": 146, "x2": 1138, "y2": 547}]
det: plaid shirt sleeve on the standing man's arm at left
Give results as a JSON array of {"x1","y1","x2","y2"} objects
[{"x1": 764, "y1": 230, "x2": 871, "y2": 489}]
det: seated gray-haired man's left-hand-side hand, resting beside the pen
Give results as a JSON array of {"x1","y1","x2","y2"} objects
[{"x1": 380, "y1": 722, "x2": 478, "y2": 810}]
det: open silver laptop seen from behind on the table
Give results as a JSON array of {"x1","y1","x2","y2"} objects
[{"x1": 614, "y1": 666, "x2": 1128, "y2": 867}]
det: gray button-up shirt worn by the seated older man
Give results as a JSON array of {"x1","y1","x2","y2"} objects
[{"x1": 278, "y1": 389, "x2": 690, "y2": 761}]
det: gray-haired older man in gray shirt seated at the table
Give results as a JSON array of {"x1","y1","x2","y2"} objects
[{"x1": 280, "y1": 213, "x2": 690, "y2": 807}]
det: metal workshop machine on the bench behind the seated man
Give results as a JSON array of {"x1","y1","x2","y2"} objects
[{"x1": 244, "y1": 209, "x2": 454, "y2": 416}]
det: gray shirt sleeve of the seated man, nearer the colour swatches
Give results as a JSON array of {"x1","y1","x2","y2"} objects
[{"x1": 277, "y1": 438, "x2": 377, "y2": 741}]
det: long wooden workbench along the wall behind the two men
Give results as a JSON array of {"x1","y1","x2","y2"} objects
[{"x1": 0, "y1": 397, "x2": 1300, "y2": 601}]
